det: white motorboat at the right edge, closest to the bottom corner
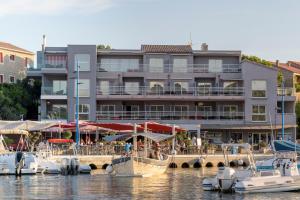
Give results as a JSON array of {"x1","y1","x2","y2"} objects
[{"x1": 234, "y1": 154, "x2": 300, "y2": 194}]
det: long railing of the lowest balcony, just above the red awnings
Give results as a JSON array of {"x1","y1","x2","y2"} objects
[{"x1": 96, "y1": 111, "x2": 244, "y2": 120}]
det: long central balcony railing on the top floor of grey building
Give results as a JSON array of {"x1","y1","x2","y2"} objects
[{"x1": 97, "y1": 63, "x2": 241, "y2": 73}]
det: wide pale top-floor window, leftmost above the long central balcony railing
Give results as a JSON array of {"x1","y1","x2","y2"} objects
[{"x1": 100, "y1": 58, "x2": 140, "y2": 72}]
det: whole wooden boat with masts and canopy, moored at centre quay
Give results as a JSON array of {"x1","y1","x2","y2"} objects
[{"x1": 109, "y1": 125, "x2": 175, "y2": 177}]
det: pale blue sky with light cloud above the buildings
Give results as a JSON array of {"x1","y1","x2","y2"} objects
[{"x1": 0, "y1": 0, "x2": 300, "y2": 62}]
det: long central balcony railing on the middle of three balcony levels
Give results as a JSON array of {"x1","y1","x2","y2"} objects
[{"x1": 97, "y1": 86, "x2": 244, "y2": 96}]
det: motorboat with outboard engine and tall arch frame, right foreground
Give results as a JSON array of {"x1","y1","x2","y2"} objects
[{"x1": 202, "y1": 143, "x2": 256, "y2": 192}]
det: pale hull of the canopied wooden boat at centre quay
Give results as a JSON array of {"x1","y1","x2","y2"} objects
[{"x1": 112, "y1": 157, "x2": 168, "y2": 177}]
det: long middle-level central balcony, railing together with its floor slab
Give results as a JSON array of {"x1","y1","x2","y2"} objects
[{"x1": 96, "y1": 86, "x2": 244, "y2": 100}]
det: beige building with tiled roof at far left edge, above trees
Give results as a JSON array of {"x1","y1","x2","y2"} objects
[{"x1": 0, "y1": 42, "x2": 34, "y2": 83}]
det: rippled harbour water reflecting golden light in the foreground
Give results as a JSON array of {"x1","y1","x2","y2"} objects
[{"x1": 0, "y1": 169, "x2": 300, "y2": 200}]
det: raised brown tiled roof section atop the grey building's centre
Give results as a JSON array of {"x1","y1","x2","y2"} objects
[{"x1": 141, "y1": 44, "x2": 193, "y2": 53}]
